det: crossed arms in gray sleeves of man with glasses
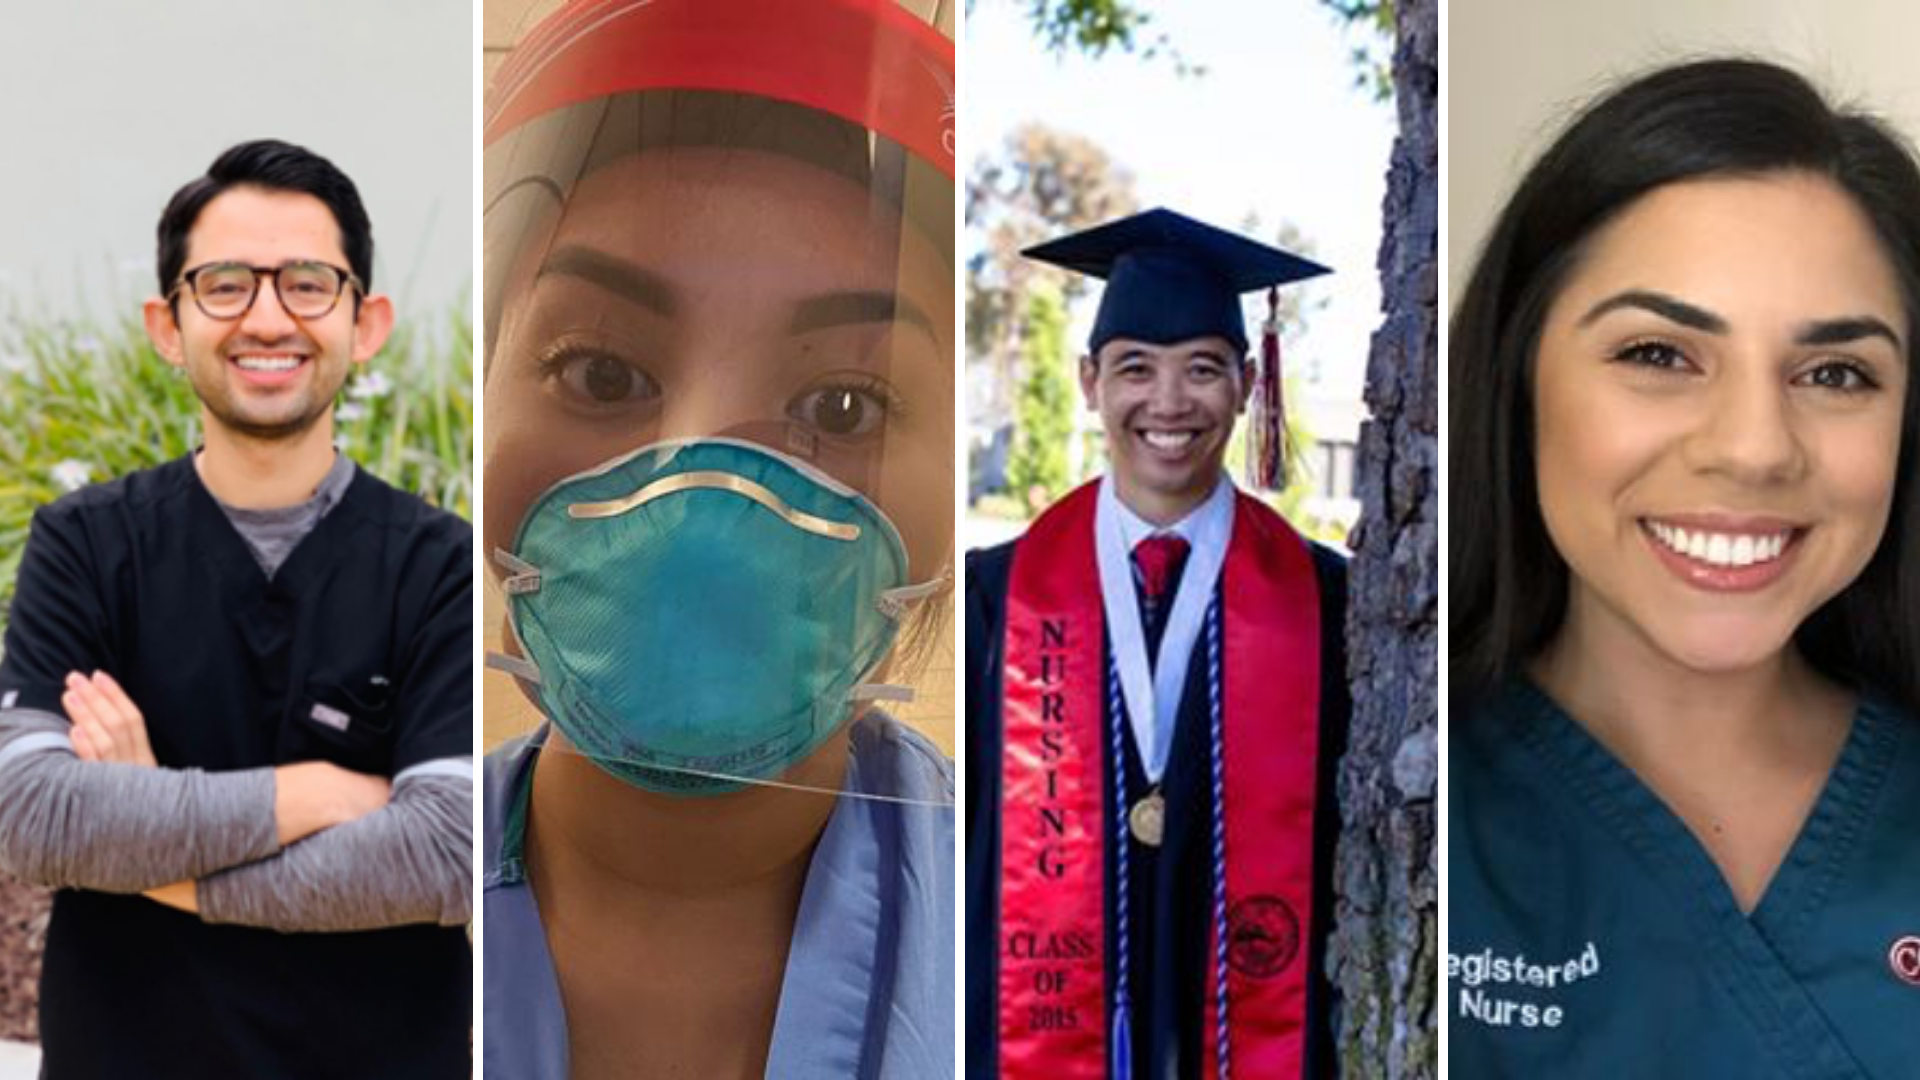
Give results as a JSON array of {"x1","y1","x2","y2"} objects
[{"x1": 0, "y1": 673, "x2": 472, "y2": 932}]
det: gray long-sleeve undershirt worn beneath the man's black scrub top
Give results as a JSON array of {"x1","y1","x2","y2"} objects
[{"x1": 0, "y1": 455, "x2": 472, "y2": 932}]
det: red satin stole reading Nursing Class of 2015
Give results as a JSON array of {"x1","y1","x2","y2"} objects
[{"x1": 998, "y1": 482, "x2": 1321, "y2": 1080}]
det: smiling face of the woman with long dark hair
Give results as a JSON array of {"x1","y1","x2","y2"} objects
[{"x1": 1534, "y1": 173, "x2": 1910, "y2": 671}]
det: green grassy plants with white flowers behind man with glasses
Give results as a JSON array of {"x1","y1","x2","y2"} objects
[{"x1": 0, "y1": 300, "x2": 474, "y2": 638}]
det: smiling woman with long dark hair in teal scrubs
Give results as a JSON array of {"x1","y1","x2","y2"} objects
[{"x1": 1446, "y1": 60, "x2": 1920, "y2": 1078}]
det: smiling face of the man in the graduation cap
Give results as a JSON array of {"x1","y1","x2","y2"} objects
[{"x1": 1081, "y1": 336, "x2": 1250, "y2": 525}]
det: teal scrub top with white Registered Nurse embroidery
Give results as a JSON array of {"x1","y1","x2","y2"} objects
[{"x1": 1446, "y1": 684, "x2": 1920, "y2": 1080}]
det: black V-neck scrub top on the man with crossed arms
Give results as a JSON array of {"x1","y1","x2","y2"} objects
[{"x1": 0, "y1": 459, "x2": 472, "y2": 1080}]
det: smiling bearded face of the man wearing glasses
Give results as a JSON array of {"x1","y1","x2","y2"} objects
[{"x1": 146, "y1": 186, "x2": 392, "y2": 444}]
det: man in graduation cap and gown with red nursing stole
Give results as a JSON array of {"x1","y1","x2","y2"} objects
[{"x1": 966, "y1": 209, "x2": 1350, "y2": 1080}]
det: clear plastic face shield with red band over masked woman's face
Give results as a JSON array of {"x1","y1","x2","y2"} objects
[{"x1": 484, "y1": 0, "x2": 956, "y2": 807}]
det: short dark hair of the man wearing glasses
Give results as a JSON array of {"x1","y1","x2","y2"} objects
[{"x1": 159, "y1": 138, "x2": 372, "y2": 296}]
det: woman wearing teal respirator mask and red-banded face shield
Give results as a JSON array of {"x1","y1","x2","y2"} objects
[{"x1": 484, "y1": 0, "x2": 954, "y2": 1076}]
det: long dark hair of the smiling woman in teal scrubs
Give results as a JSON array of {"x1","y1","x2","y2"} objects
[{"x1": 1448, "y1": 60, "x2": 1920, "y2": 709}]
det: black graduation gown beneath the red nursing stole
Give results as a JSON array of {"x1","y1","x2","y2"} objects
[{"x1": 966, "y1": 540, "x2": 1352, "y2": 1080}]
